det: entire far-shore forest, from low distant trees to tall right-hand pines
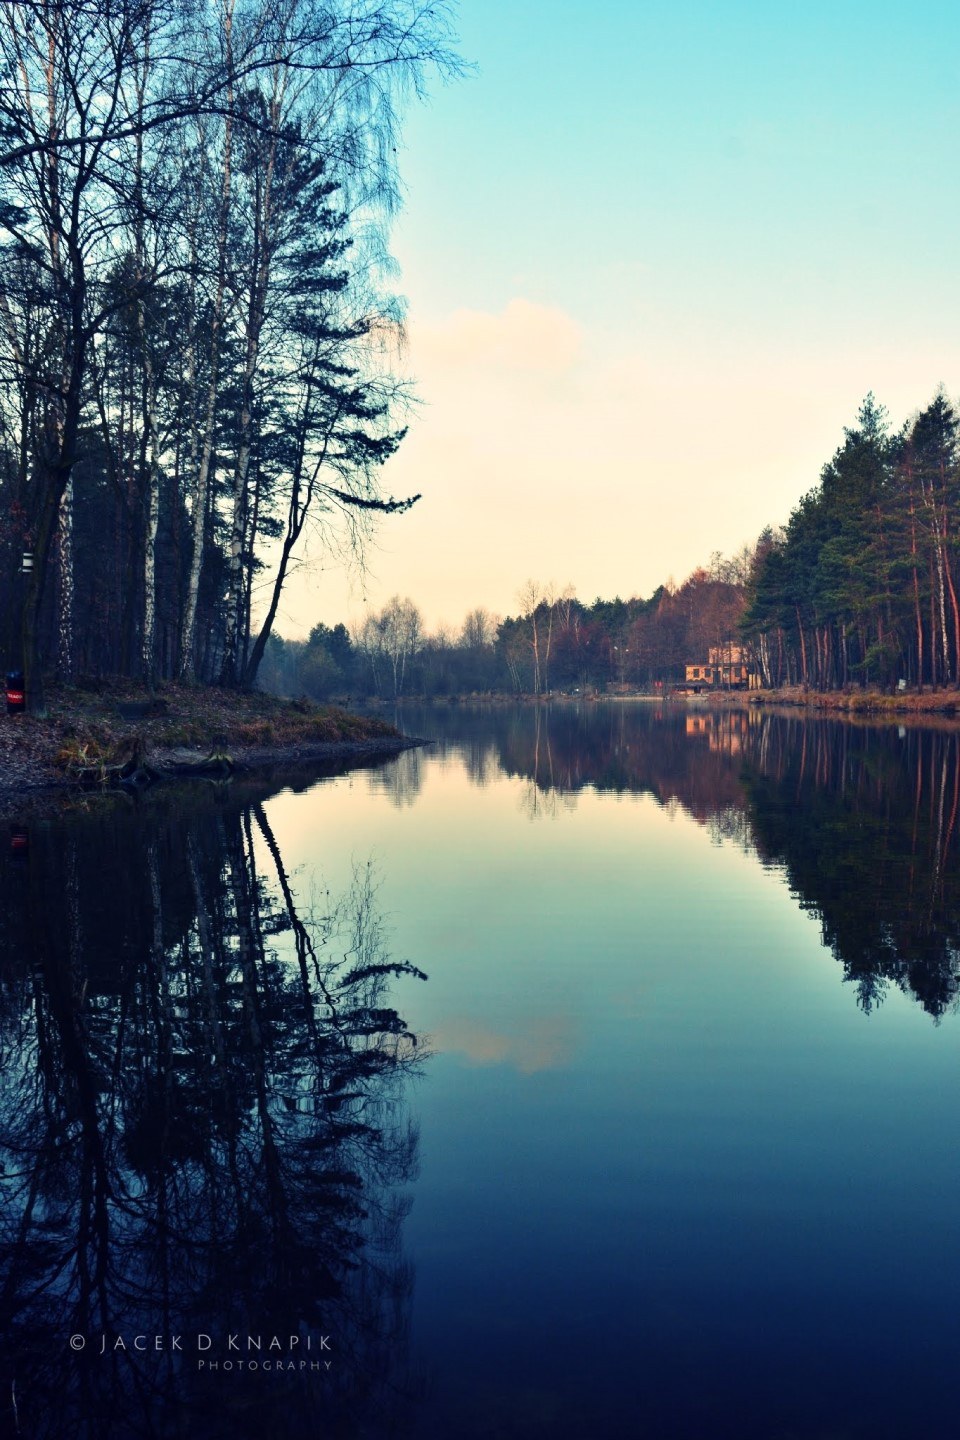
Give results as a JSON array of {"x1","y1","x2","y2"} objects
[{"x1": 261, "y1": 390, "x2": 960, "y2": 698}]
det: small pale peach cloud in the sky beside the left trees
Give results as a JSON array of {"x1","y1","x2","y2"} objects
[{"x1": 413, "y1": 298, "x2": 581, "y2": 374}]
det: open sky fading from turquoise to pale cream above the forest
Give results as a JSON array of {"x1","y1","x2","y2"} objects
[{"x1": 276, "y1": 0, "x2": 960, "y2": 638}]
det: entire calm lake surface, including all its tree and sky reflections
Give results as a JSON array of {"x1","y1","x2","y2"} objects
[{"x1": 0, "y1": 706, "x2": 960, "y2": 1440}]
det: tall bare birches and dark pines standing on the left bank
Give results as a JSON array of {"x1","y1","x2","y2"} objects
[{"x1": 0, "y1": 0, "x2": 456, "y2": 708}]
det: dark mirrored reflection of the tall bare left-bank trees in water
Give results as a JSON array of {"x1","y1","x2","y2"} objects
[{"x1": 0, "y1": 799, "x2": 420, "y2": 1440}]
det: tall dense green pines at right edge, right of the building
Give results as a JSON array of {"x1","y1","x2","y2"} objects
[{"x1": 744, "y1": 392, "x2": 960, "y2": 690}]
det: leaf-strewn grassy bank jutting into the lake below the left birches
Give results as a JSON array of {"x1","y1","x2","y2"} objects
[{"x1": 0, "y1": 683, "x2": 402, "y2": 788}]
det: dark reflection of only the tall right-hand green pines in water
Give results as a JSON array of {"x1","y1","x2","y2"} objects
[{"x1": 744, "y1": 721, "x2": 960, "y2": 1017}]
